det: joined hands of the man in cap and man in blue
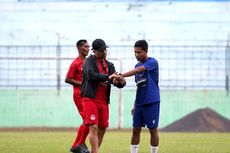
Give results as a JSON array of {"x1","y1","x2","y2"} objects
[{"x1": 109, "y1": 72, "x2": 126, "y2": 88}]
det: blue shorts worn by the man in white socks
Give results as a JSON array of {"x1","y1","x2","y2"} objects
[{"x1": 133, "y1": 102, "x2": 160, "y2": 129}]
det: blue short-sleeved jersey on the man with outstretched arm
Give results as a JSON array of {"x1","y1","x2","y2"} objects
[{"x1": 135, "y1": 57, "x2": 160, "y2": 106}]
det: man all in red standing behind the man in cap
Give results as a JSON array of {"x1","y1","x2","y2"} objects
[{"x1": 65, "y1": 39, "x2": 89, "y2": 153}]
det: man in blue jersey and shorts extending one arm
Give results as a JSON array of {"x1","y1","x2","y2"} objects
[{"x1": 120, "y1": 40, "x2": 160, "y2": 153}]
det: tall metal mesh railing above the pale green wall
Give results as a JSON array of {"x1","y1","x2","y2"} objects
[{"x1": 0, "y1": 44, "x2": 230, "y2": 93}]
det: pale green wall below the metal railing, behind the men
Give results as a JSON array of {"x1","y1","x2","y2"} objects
[{"x1": 0, "y1": 88, "x2": 230, "y2": 128}]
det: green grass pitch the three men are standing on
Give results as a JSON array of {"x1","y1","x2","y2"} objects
[{"x1": 0, "y1": 130, "x2": 230, "y2": 153}]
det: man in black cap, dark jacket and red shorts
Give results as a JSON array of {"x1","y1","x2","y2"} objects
[{"x1": 81, "y1": 39, "x2": 126, "y2": 153}]
